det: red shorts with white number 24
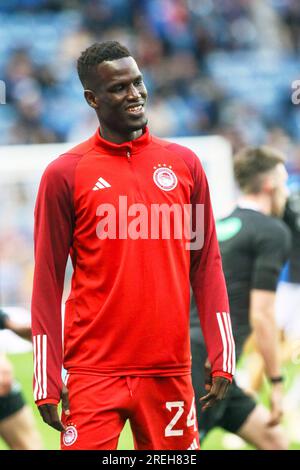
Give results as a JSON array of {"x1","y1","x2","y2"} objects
[{"x1": 61, "y1": 374, "x2": 199, "y2": 450}]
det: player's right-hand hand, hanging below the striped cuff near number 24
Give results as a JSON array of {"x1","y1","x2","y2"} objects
[{"x1": 200, "y1": 359, "x2": 230, "y2": 411}]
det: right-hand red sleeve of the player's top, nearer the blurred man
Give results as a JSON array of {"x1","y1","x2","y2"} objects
[{"x1": 190, "y1": 157, "x2": 235, "y2": 378}]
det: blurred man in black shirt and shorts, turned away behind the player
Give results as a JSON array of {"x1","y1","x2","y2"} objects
[{"x1": 191, "y1": 147, "x2": 290, "y2": 450}]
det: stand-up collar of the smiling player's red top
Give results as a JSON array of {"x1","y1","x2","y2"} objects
[{"x1": 94, "y1": 127, "x2": 151, "y2": 156}]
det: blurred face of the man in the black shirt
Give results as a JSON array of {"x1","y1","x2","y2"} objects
[{"x1": 271, "y1": 163, "x2": 288, "y2": 217}]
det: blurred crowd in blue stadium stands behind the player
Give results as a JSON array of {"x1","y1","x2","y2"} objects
[{"x1": 0, "y1": 0, "x2": 300, "y2": 305}]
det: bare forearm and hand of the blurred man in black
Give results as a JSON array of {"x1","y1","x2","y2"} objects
[{"x1": 250, "y1": 289, "x2": 283, "y2": 426}]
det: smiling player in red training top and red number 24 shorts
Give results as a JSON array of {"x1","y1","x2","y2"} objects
[{"x1": 32, "y1": 41, "x2": 234, "y2": 449}]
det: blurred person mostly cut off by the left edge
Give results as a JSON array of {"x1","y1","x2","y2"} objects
[{"x1": 0, "y1": 310, "x2": 41, "y2": 450}]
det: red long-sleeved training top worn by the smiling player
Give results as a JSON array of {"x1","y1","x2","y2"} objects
[{"x1": 32, "y1": 130, "x2": 234, "y2": 400}]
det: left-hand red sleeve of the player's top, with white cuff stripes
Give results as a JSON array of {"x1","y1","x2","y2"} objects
[{"x1": 31, "y1": 155, "x2": 76, "y2": 404}]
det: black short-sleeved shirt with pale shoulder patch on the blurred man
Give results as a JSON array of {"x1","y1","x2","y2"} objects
[{"x1": 191, "y1": 208, "x2": 290, "y2": 359}]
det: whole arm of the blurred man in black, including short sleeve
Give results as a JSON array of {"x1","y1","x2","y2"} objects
[{"x1": 249, "y1": 219, "x2": 291, "y2": 426}]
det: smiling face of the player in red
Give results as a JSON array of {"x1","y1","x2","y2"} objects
[{"x1": 86, "y1": 57, "x2": 147, "y2": 136}]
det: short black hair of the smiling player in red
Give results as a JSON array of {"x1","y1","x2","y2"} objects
[{"x1": 77, "y1": 41, "x2": 131, "y2": 88}]
